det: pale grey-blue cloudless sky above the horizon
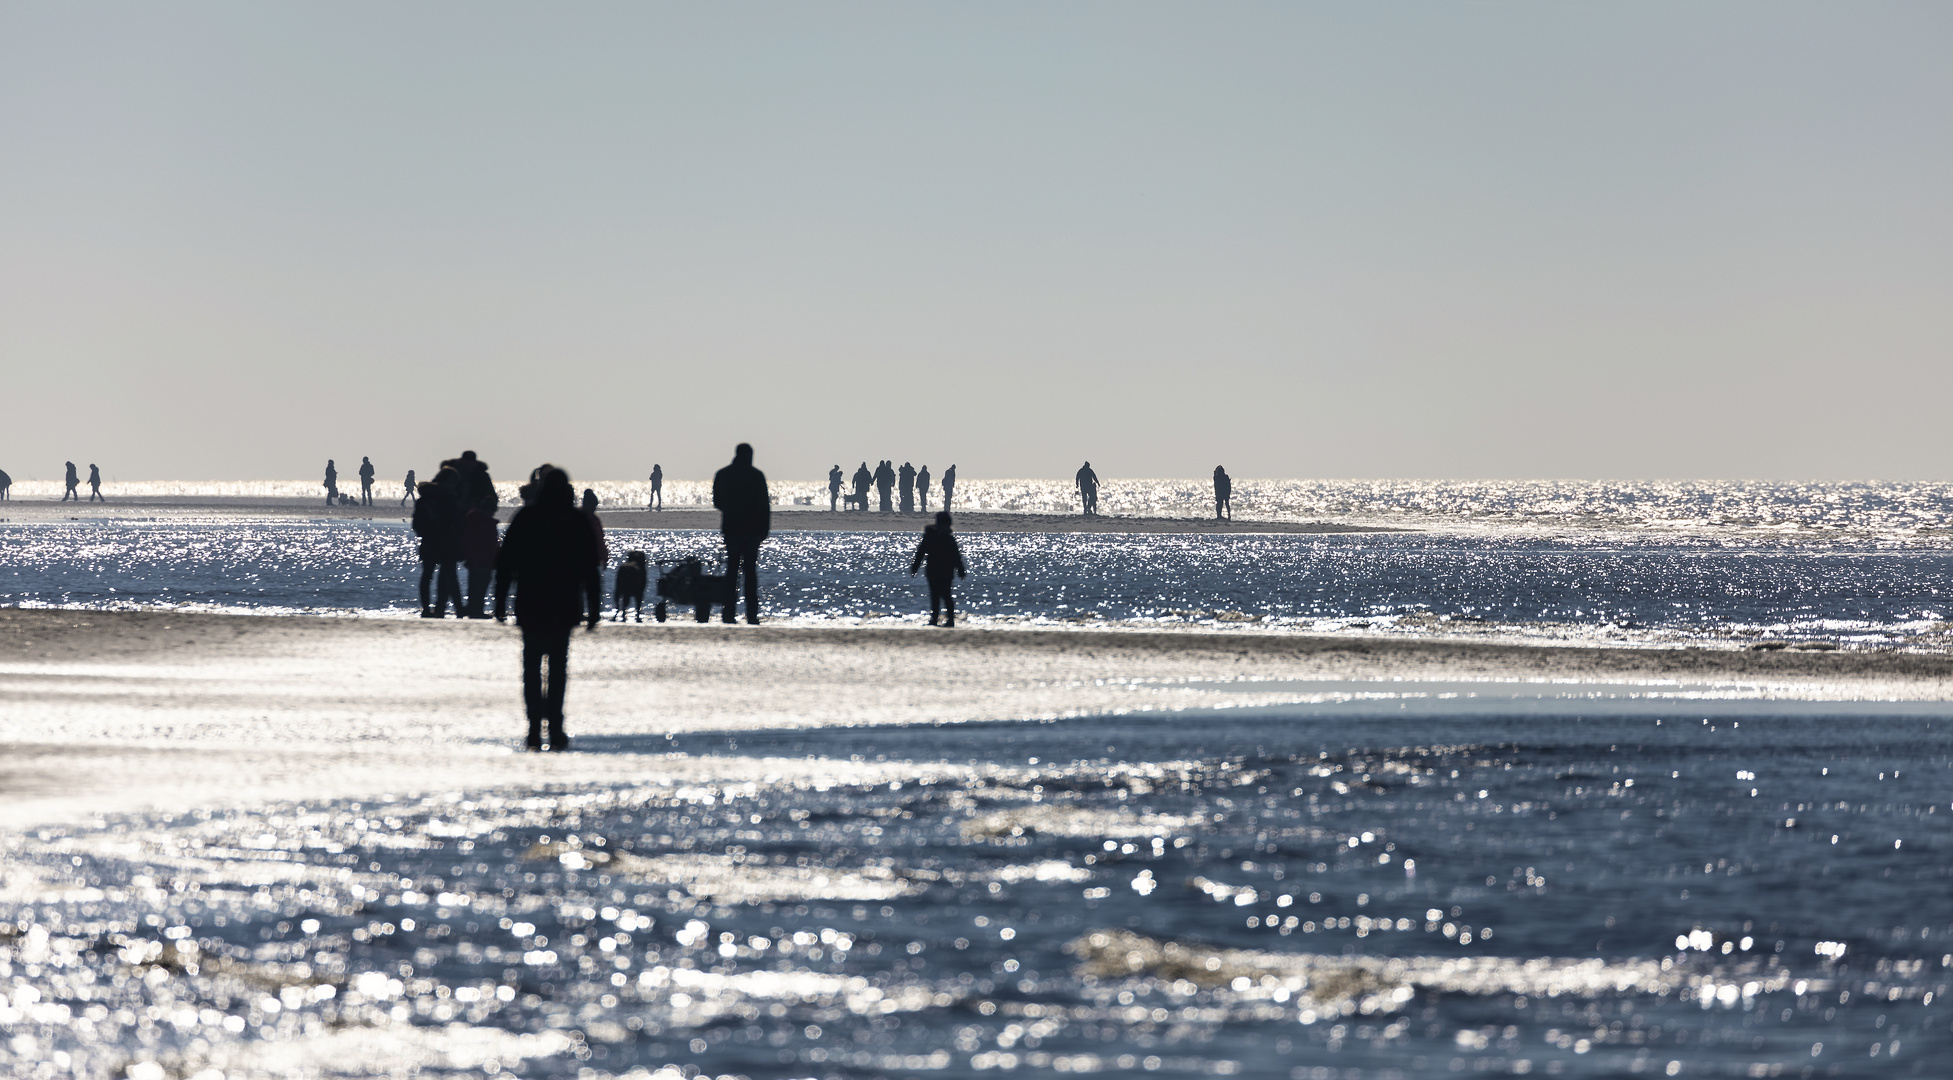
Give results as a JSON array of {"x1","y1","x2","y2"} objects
[{"x1": 0, "y1": 0, "x2": 1953, "y2": 480}]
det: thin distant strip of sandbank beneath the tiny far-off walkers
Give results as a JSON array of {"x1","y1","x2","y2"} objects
[{"x1": 0, "y1": 496, "x2": 1404, "y2": 533}]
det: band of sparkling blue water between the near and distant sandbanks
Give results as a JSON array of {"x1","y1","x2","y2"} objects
[{"x1": 0, "y1": 521, "x2": 1953, "y2": 644}]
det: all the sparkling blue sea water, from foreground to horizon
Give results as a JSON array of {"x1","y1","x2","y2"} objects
[{"x1": 0, "y1": 480, "x2": 1953, "y2": 1080}]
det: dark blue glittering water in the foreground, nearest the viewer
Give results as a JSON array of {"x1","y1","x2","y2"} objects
[{"x1": 0, "y1": 701, "x2": 1953, "y2": 1080}]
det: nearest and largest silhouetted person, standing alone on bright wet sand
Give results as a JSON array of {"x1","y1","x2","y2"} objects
[{"x1": 494, "y1": 465, "x2": 603, "y2": 750}]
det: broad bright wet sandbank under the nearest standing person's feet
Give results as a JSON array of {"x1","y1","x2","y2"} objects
[{"x1": 0, "y1": 609, "x2": 1953, "y2": 826}]
